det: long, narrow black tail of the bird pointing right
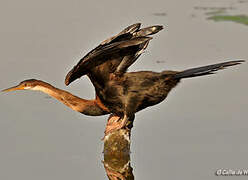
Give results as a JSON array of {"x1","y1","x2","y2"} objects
[{"x1": 174, "y1": 60, "x2": 245, "y2": 79}]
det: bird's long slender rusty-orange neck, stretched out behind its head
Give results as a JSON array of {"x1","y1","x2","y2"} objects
[{"x1": 32, "y1": 81, "x2": 109, "y2": 116}]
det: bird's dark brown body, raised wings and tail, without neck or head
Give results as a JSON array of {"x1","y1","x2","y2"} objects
[{"x1": 65, "y1": 24, "x2": 243, "y2": 128}]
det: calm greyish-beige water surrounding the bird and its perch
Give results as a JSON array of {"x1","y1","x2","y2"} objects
[{"x1": 0, "y1": 0, "x2": 248, "y2": 180}]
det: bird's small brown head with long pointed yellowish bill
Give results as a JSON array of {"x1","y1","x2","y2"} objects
[{"x1": 2, "y1": 79, "x2": 42, "y2": 92}]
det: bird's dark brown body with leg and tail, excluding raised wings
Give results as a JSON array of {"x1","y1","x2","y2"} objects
[{"x1": 96, "y1": 60, "x2": 243, "y2": 126}]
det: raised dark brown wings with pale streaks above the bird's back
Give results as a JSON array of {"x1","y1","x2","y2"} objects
[{"x1": 65, "y1": 23, "x2": 163, "y2": 85}]
